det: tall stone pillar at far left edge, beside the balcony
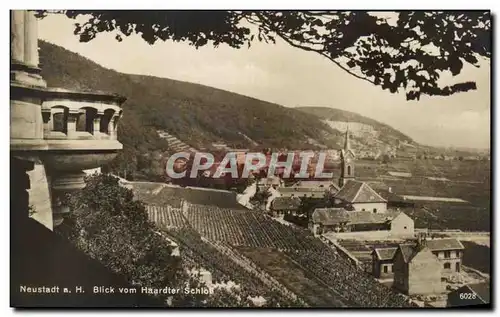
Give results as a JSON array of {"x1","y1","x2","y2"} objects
[{"x1": 10, "y1": 10, "x2": 47, "y2": 230}]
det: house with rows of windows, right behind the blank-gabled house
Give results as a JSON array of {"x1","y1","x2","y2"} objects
[{"x1": 426, "y1": 239, "x2": 464, "y2": 277}]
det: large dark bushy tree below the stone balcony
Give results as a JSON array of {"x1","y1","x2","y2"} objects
[{"x1": 58, "y1": 175, "x2": 185, "y2": 288}]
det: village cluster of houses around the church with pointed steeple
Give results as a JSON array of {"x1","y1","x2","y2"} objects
[{"x1": 228, "y1": 130, "x2": 489, "y2": 307}]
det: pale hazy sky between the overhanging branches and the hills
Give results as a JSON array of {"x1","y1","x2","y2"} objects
[{"x1": 38, "y1": 15, "x2": 490, "y2": 148}]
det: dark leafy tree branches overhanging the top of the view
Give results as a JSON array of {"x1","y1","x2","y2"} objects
[{"x1": 39, "y1": 10, "x2": 491, "y2": 100}]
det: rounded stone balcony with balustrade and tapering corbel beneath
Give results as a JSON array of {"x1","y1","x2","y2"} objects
[{"x1": 41, "y1": 88, "x2": 125, "y2": 226}]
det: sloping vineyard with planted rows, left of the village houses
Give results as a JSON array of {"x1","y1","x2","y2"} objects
[{"x1": 148, "y1": 200, "x2": 409, "y2": 307}]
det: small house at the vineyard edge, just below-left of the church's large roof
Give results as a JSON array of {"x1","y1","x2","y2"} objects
[{"x1": 309, "y1": 208, "x2": 349, "y2": 235}]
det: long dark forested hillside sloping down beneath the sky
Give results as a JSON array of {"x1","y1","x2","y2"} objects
[{"x1": 39, "y1": 41, "x2": 426, "y2": 180}]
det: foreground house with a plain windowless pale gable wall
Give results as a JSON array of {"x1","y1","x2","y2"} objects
[{"x1": 393, "y1": 240, "x2": 444, "y2": 295}]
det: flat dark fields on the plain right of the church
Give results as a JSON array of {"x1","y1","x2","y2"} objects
[{"x1": 356, "y1": 160, "x2": 491, "y2": 231}]
